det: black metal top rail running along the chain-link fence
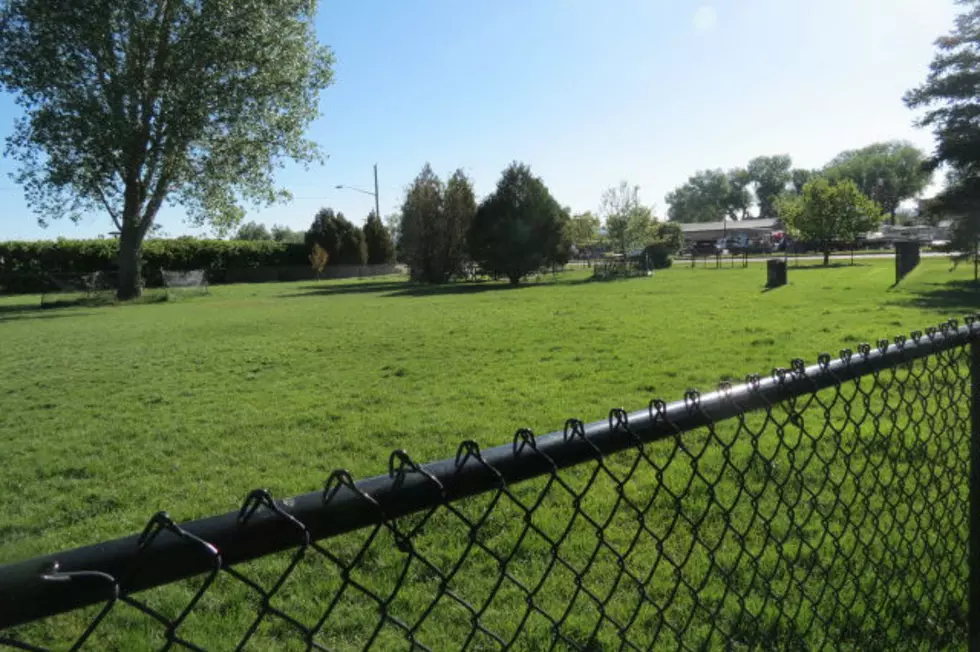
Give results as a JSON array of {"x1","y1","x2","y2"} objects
[{"x1": 0, "y1": 316, "x2": 980, "y2": 628}]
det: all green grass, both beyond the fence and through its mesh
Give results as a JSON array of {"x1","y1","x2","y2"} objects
[{"x1": 0, "y1": 259, "x2": 980, "y2": 649}]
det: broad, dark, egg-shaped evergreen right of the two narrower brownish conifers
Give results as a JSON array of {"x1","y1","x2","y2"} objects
[{"x1": 469, "y1": 163, "x2": 568, "y2": 285}]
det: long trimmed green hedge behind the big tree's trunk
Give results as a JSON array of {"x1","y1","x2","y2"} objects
[{"x1": 0, "y1": 238, "x2": 309, "y2": 292}]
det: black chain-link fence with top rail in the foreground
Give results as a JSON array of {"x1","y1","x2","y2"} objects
[{"x1": 0, "y1": 319, "x2": 980, "y2": 650}]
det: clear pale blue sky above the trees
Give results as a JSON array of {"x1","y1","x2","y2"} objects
[{"x1": 0, "y1": 0, "x2": 955, "y2": 240}]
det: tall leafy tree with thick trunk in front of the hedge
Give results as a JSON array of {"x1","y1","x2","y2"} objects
[{"x1": 0, "y1": 0, "x2": 332, "y2": 299}]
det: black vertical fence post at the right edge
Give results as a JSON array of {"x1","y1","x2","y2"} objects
[{"x1": 967, "y1": 339, "x2": 980, "y2": 652}]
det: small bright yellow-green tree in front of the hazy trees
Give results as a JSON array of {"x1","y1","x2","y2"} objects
[{"x1": 775, "y1": 177, "x2": 881, "y2": 265}]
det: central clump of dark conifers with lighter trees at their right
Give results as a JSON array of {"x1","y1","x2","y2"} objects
[{"x1": 391, "y1": 162, "x2": 683, "y2": 285}]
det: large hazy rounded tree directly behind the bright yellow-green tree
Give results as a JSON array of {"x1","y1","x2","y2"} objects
[{"x1": 822, "y1": 141, "x2": 932, "y2": 221}]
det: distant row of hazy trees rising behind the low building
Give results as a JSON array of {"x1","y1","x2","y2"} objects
[{"x1": 667, "y1": 141, "x2": 932, "y2": 223}]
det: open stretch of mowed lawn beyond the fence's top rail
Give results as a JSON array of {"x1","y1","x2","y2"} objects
[{"x1": 0, "y1": 259, "x2": 980, "y2": 648}]
